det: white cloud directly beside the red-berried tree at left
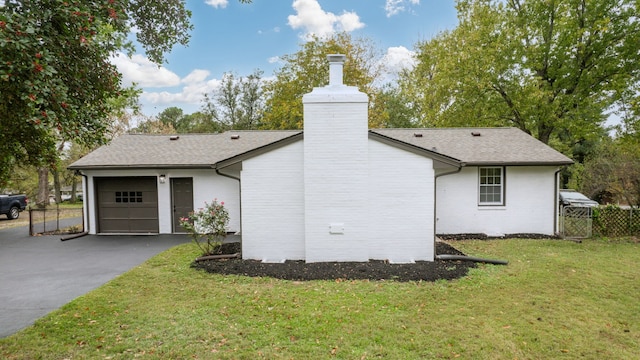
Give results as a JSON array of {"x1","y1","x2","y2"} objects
[{"x1": 111, "y1": 53, "x2": 180, "y2": 87}]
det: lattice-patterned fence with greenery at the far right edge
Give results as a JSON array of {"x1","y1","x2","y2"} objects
[{"x1": 593, "y1": 205, "x2": 640, "y2": 237}]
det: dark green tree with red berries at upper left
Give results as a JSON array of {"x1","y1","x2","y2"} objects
[{"x1": 0, "y1": 0, "x2": 250, "y2": 187}]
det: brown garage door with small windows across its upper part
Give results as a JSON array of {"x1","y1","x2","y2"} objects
[{"x1": 94, "y1": 177, "x2": 159, "y2": 234}]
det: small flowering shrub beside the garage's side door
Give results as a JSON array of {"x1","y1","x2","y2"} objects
[{"x1": 180, "y1": 199, "x2": 229, "y2": 256}]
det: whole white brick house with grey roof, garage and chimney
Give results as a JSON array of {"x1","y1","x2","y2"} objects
[{"x1": 70, "y1": 55, "x2": 571, "y2": 262}]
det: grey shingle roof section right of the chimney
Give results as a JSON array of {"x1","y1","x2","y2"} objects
[{"x1": 371, "y1": 128, "x2": 573, "y2": 165}]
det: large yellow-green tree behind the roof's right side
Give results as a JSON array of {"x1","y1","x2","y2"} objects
[{"x1": 401, "y1": 0, "x2": 640, "y2": 148}]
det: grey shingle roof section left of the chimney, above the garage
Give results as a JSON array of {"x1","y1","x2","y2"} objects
[{"x1": 69, "y1": 130, "x2": 301, "y2": 169}]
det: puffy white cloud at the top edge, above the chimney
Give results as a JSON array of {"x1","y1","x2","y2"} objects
[{"x1": 288, "y1": 0, "x2": 364, "y2": 38}]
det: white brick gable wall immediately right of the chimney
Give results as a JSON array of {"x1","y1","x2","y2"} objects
[{"x1": 368, "y1": 140, "x2": 434, "y2": 263}]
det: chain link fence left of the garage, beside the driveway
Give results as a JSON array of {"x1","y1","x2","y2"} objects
[{"x1": 29, "y1": 206, "x2": 84, "y2": 236}]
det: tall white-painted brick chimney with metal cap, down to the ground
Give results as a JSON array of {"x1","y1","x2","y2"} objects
[{"x1": 302, "y1": 55, "x2": 369, "y2": 262}]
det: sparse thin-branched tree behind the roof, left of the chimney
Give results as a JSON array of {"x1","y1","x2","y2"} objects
[{"x1": 203, "y1": 70, "x2": 264, "y2": 132}]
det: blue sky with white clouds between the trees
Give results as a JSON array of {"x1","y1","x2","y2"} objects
[{"x1": 114, "y1": 0, "x2": 457, "y2": 115}]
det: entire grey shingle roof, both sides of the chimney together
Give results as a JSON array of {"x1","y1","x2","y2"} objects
[{"x1": 69, "y1": 128, "x2": 572, "y2": 169}]
